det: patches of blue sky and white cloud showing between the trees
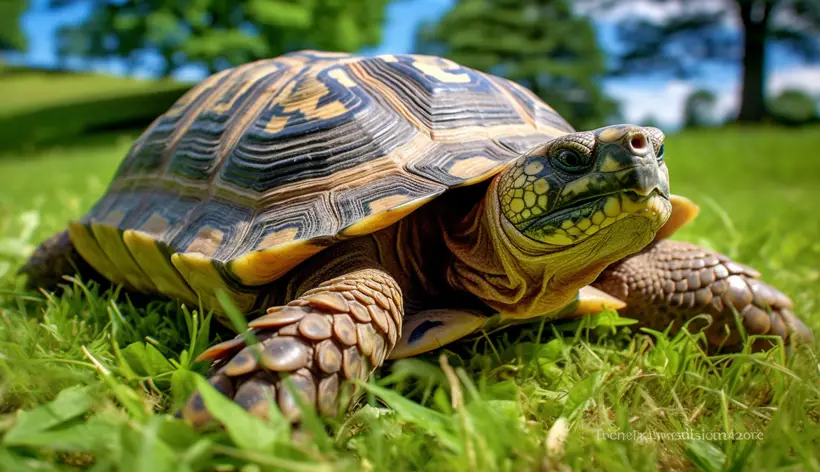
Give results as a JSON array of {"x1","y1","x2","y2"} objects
[{"x1": 9, "y1": 0, "x2": 820, "y2": 126}]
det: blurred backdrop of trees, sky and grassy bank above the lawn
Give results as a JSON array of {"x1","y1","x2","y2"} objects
[{"x1": 0, "y1": 0, "x2": 820, "y2": 148}]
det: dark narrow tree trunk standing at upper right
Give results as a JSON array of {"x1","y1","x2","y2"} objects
[{"x1": 737, "y1": 0, "x2": 776, "y2": 123}]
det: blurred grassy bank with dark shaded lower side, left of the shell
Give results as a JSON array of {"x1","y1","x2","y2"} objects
[{"x1": 0, "y1": 70, "x2": 191, "y2": 149}]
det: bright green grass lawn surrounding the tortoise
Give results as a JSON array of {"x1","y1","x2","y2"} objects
[{"x1": 0, "y1": 128, "x2": 820, "y2": 471}]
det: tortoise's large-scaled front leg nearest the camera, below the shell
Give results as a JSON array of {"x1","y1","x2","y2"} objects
[{"x1": 182, "y1": 269, "x2": 403, "y2": 425}]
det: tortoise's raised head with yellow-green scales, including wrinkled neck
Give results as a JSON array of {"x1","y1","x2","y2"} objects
[{"x1": 474, "y1": 125, "x2": 672, "y2": 318}]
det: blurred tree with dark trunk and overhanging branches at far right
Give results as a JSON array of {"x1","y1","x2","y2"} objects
[{"x1": 576, "y1": 0, "x2": 820, "y2": 122}]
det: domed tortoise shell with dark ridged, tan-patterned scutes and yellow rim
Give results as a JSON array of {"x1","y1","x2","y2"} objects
[{"x1": 69, "y1": 51, "x2": 573, "y2": 310}]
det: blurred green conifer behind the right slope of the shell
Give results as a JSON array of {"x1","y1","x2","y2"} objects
[{"x1": 417, "y1": 0, "x2": 616, "y2": 128}]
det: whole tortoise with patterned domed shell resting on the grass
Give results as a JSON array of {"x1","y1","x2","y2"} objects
[{"x1": 22, "y1": 51, "x2": 811, "y2": 424}]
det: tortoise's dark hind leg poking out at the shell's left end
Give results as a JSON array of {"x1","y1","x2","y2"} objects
[{"x1": 18, "y1": 231, "x2": 105, "y2": 290}]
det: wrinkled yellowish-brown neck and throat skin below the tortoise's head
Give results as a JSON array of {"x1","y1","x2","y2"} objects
[{"x1": 442, "y1": 179, "x2": 655, "y2": 319}]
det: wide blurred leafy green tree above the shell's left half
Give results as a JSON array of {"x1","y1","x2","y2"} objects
[{"x1": 51, "y1": 0, "x2": 389, "y2": 75}]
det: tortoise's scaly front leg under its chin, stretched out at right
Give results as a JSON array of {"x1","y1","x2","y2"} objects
[{"x1": 593, "y1": 240, "x2": 812, "y2": 348}]
